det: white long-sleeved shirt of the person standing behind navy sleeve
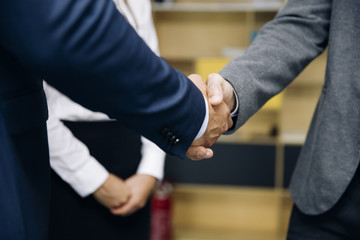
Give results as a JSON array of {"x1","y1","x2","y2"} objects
[{"x1": 44, "y1": 0, "x2": 167, "y2": 197}]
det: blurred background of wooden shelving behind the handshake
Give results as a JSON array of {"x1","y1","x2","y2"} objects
[{"x1": 152, "y1": 0, "x2": 326, "y2": 240}]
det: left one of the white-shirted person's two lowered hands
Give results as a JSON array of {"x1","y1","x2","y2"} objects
[{"x1": 93, "y1": 173, "x2": 130, "y2": 209}]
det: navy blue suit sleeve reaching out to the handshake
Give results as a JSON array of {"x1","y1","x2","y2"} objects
[{"x1": 0, "y1": 0, "x2": 205, "y2": 157}]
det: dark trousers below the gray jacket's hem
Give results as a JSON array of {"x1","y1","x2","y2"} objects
[{"x1": 287, "y1": 168, "x2": 360, "y2": 240}]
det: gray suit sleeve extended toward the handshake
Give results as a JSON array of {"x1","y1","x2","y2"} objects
[{"x1": 220, "y1": 0, "x2": 331, "y2": 131}]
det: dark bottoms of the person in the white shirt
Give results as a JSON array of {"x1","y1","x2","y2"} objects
[{"x1": 49, "y1": 122, "x2": 150, "y2": 240}]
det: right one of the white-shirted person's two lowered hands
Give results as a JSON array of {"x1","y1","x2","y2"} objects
[{"x1": 110, "y1": 174, "x2": 156, "y2": 216}]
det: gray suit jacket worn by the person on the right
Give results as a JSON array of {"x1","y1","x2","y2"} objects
[{"x1": 220, "y1": 0, "x2": 360, "y2": 214}]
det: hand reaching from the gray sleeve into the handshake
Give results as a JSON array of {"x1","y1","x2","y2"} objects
[{"x1": 206, "y1": 73, "x2": 236, "y2": 111}]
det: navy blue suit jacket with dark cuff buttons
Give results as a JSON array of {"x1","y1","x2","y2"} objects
[{"x1": 0, "y1": 0, "x2": 205, "y2": 240}]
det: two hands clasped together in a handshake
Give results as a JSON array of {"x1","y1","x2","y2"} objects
[{"x1": 186, "y1": 73, "x2": 236, "y2": 160}]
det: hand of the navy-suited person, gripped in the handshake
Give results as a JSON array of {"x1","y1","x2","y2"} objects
[{"x1": 186, "y1": 74, "x2": 233, "y2": 160}]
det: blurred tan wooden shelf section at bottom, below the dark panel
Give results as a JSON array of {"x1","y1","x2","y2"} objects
[{"x1": 173, "y1": 184, "x2": 292, "y2": 240}]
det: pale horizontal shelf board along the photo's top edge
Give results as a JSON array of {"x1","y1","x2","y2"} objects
[{"x1": 152, "y1": 1, "x2": 283, "y2": 12}]
